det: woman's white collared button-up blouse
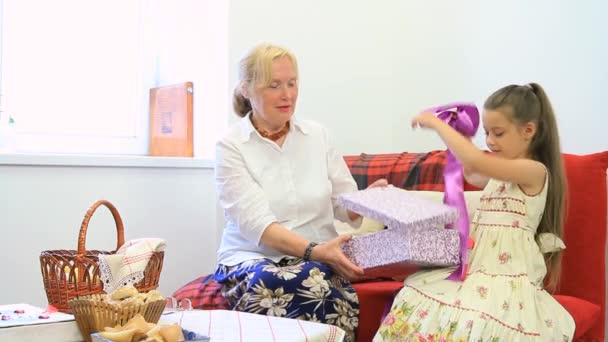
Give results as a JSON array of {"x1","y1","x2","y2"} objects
[{"x1": 215, "y1": 114, "x2": 361, "y2": 266}]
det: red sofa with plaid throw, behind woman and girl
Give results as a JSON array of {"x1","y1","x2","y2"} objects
[{"x1": 174, "y1": 151, "x2": 608, "y2": 342}]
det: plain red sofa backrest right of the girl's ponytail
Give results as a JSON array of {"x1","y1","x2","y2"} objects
[{"x1": 558, "y1": 152, "x2": 608, "y2": 341}]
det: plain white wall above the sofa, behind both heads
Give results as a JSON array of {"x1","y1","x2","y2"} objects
[{"x1": 230, "y1": 0, "x2": 608, "y2": 154}]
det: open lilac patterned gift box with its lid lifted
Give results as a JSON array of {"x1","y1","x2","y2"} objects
[{"x1": 338, "y1": 185, "x2": 460, "y2": 277}]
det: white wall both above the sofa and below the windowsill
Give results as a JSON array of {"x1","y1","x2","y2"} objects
[{"x1": 0, "y1": 0, "x2": 608, "y2": 305}]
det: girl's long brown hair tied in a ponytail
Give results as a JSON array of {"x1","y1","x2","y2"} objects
[{"x1": 484, "y1": 83, "x2": 567, "y2": 290}]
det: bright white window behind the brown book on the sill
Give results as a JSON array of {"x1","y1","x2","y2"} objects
[{"x1": 0, "y1": 0, "x2": 229, "y2": 158}]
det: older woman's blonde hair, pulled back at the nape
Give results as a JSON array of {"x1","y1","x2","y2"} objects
[{"x1": 232, "y1": 43, "x2": 298, "y2": 117}]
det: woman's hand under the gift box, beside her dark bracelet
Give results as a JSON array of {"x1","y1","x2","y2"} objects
[{"x1": 311, "y1": 235, "x2": 363, "y2": 281}]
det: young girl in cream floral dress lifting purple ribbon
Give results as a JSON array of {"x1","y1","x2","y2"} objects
[{"x1": 374, "y1": 83, "x2": 574, "y2": 341}]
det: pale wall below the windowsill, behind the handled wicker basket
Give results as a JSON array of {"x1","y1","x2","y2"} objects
[{"x1": 0, "y1": 166, "x2": 217, "y2": 305}]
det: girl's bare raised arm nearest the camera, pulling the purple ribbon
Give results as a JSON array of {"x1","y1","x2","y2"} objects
[{"x1": 412, "y1": 113, "x2": 545, "y2": 193}]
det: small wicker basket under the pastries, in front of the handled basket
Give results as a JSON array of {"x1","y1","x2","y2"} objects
[{"x1": 69, "y1": 295, "x2": 166, "y2": 342}]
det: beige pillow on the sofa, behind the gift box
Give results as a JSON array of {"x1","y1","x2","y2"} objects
[{"x1": 335, "y1": 190, "x2": 483, "y2": 236}]
